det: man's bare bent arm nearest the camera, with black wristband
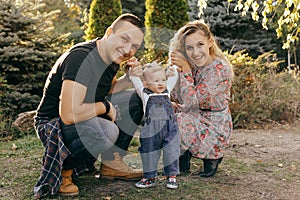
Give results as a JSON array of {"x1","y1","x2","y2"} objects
[{"x1": 59, "y1": 80, "x2": 115, "y2": 124}]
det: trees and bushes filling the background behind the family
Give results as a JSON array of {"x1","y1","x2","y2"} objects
[{"x1": 0, "y1": 0, "x2": 300, "y2": 139}]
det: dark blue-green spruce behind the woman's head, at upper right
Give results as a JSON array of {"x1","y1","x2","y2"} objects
[{"x1": 201, "y1": 0, "x2": 285, "y2": 59}]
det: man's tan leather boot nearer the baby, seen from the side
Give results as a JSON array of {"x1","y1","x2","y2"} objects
[{"x1": 100, "y1": 153, "x2": 143, "y2": 181}]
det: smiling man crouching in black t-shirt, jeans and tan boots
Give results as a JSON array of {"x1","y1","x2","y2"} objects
[{"x1": 34, "y1": 14, "x2": 144, "y2": 198}]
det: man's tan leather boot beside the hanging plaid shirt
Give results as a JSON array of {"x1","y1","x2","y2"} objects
[{"x1": 59, "y1": 169, "x2": 79, "y2": 196}]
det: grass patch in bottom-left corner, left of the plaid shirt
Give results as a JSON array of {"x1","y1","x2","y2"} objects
[{"x1": 0, "y1": 136, "x2": 43, "y2": 199}]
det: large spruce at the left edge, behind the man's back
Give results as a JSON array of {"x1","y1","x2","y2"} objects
[{"x1": 0, "y1": 0, "x2": 65, "y2": 116}]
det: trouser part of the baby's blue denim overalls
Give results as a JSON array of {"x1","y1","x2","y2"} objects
[{"x1": 139, "y1": 117, "x2": 180, "y2": 178}]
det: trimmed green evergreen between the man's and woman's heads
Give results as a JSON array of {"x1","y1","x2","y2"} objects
[{"x1": 145, "y1": 0, "x2": 189, "y2": 61}]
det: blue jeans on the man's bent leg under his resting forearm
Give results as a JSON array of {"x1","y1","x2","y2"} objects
[{"x1": 62, "y1": 117, "x2": 119, "y2": 169}]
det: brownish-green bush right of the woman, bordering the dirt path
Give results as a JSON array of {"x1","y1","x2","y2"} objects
[{"x1": 229, "y1": 51, "x2": 300, "y2": 128}]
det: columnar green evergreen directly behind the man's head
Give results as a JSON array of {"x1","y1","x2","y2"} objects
[{"x1": 85, "y1": 0, "x2": 122, "y2": 40}]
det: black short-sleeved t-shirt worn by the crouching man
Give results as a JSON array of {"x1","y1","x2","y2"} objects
[{"x1": 37, "y1": 39, "x2": 119, "y2": 119}]
